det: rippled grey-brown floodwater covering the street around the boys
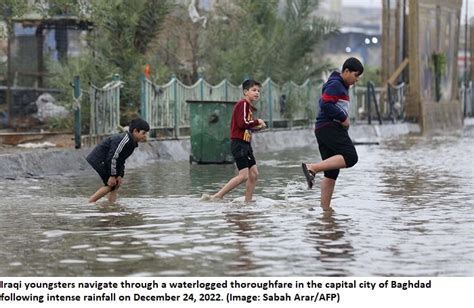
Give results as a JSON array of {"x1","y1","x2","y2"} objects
[{"x1": 0, "y1": 126, "x2": 474, "y2": 276}]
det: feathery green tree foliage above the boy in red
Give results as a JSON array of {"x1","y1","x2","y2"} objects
[{"x1": 201, "y1": 0, "x2": 337, "y2": 84}]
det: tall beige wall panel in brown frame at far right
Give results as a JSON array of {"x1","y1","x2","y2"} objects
[{"x1": 406, "y1": 0, "x2": 463, "y2": 133}]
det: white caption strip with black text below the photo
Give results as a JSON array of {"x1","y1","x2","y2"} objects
[{"x1": 0, "y1": 277, "x2": 474, "y2": 308}]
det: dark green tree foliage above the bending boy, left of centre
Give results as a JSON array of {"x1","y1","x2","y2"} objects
[{"x1": 45, "y1": 0, "x2": 170, "y2": 123}]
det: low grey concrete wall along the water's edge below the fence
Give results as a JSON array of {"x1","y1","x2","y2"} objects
[{"x1": 0, "y1": 123, "x2": 420, "y2": 179}]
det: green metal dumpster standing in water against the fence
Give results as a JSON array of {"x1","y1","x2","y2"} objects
[{"x1": 186, "y1": 100, "x2": 235, "y2": 164}]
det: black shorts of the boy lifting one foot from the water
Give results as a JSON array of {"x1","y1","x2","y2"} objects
[{"x1": 315, "y1": 123, "x2": 358, "y2": 180}]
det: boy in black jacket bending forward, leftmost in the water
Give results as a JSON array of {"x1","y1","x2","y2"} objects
[{"x1": 86, "y1": 118, "x2": 150, "y2": 202}]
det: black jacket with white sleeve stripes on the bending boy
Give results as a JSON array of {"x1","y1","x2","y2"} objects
[{"x1": 86, "y1": 132, "x2": 138, "y2": 177}]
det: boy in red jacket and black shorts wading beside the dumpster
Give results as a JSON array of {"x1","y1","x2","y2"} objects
[{"x1": 201, "y1": 80, "x2": 267, "y2": 202}]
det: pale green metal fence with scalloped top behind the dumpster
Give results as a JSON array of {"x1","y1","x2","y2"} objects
[{"x1": 141, "y1": 77, "x2": 321, "y2": 137}]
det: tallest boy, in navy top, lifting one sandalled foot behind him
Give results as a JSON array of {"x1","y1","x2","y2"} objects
[{"x1": 301, "y1": 58, "x2": 364, "y2": 210}]
